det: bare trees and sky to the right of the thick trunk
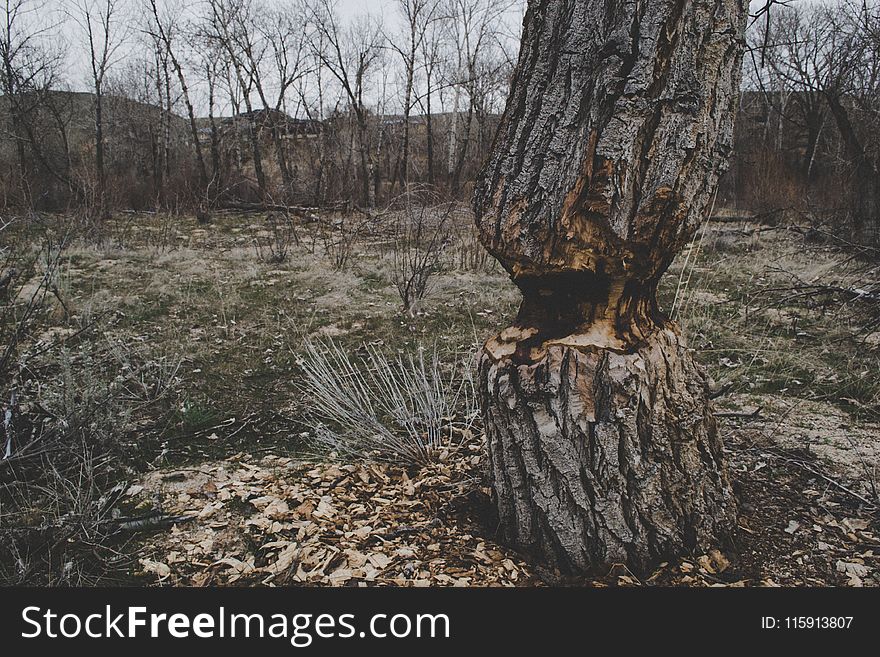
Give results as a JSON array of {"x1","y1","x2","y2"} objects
[{"x1": 722, "y1": 0, "x2": 880, "y2": 238}]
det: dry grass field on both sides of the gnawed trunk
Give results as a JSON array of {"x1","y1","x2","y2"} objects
[{"x1": 3, "y1": 214, "x2": 880, "y2": 584}]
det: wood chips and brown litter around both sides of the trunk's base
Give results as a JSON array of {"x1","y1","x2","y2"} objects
[{"x1": 129, "y1": 430, "x2": 880, "y2": 587}]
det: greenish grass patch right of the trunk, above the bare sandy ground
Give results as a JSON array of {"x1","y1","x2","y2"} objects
[{"x1": 660, "y1": 227, "x2": 880, "y2": 419}]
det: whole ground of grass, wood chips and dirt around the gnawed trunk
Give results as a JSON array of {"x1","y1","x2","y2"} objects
[{"x1": 0, "y1": 208, "x2": 880, "y2": 586}]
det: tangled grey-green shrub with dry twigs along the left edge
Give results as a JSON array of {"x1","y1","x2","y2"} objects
[{"x1": 0, "y1": 222, "x2": 181, "y2": 585}]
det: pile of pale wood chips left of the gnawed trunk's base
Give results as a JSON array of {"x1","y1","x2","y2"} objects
[{"x1": 135, "y1": 438, "x2": 537, "y2": 587}]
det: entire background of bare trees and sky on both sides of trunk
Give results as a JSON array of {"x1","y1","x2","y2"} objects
[{"x1": 0, "y1": 0, "x2": 880, "y2": 242}]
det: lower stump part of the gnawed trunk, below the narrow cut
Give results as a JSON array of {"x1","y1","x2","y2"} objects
[{"x1": 479, "y1": 328, "x2": 736, "y2": 574}]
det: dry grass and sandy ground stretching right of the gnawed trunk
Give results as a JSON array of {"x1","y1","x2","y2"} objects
[{"x1": 662, "y1": 218, "x2": 880, "y2": 498}]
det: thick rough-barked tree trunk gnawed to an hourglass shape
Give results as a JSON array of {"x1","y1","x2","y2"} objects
[{"x1": 475, "y1": 0, "x2": 746, "y2": 573}]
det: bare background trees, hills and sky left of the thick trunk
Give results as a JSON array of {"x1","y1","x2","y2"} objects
[{"x1": 0, "y1": 0, "x2": 522, "y2": 218}]
